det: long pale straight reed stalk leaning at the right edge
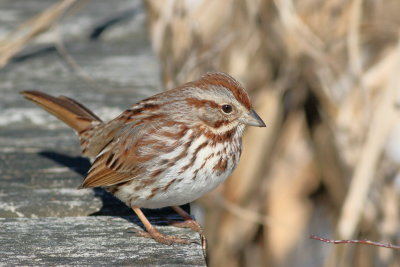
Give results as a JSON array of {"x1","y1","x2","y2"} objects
[{"x1": 328, "y1": 37, "x2": 400, "y2": 266}]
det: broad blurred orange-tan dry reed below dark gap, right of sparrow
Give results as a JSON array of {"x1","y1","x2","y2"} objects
[{"x1": 264, "y1": 113, "x2": 319, "y2": 266}]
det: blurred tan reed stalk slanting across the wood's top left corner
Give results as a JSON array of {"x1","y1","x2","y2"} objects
[{"x1": 0, "y1": 0, "x2": 77, "y2": 68}]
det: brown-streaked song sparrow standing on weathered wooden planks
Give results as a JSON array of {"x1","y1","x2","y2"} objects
[{"x1": 21, "y1": 72, "x2": 265, "y2": 244}]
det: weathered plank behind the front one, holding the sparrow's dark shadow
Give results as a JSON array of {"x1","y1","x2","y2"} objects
[{"x1": 0, "y1": 151, "x2": 192, "y2": 218}]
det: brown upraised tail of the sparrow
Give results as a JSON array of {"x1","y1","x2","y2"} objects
[{"x1": 21, "y1": 91, "x2": 101, "y2": 133}]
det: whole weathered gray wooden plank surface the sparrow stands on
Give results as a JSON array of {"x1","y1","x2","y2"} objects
[{"x1": 0, "y1": 0, "x2": 205, "y2": 266}]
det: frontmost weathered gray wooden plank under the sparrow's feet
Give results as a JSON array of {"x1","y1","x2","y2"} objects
[{"x1": 0, "y1": 216, "x2": 205, "y2": 266}]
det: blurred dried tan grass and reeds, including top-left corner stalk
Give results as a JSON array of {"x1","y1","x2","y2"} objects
[{"x1": 0, "y1": 0, "x2": 400, "y2": 267}]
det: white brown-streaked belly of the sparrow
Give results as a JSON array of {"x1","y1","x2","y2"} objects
[{"x1": 115, "y1": 132, "x2": 241, "y2": 208}]
